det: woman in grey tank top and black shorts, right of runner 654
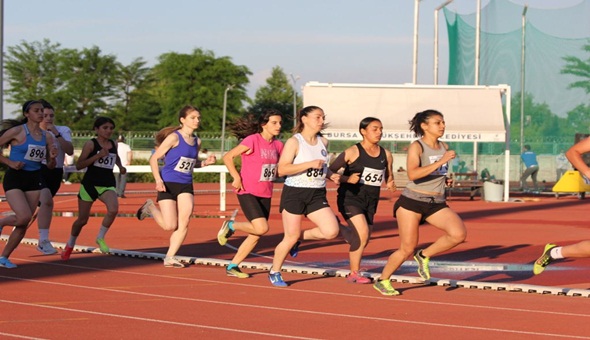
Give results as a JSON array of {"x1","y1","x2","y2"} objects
[{"x1": 373, "y1": 110, "x2": 467, "y2": 296}]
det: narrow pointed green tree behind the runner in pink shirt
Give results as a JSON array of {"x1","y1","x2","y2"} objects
[{"x1": 248, "y1": 66, "x2": 302, "y2": 131}]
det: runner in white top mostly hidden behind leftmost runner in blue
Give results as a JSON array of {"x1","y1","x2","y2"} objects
[{"x1": 37, "y1": 100, "x2": 74, "y2": 255}]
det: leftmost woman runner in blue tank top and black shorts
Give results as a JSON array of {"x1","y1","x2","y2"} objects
[{"x1": 0, "y1": 100, "x2": 57, "y2": 269}]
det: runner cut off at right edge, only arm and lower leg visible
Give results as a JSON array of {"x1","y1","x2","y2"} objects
[{"x1": 533, "y1": 138, "x2": 590, "y2": 275}]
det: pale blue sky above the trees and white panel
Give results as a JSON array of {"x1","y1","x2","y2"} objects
[{"x1": 0, "y1": 0, "x2": 581, "y2": 116}]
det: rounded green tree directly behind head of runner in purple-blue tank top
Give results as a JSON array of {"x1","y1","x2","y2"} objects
[{"x1": 153, "y1": 48, "x2": 252, "y2": 131}]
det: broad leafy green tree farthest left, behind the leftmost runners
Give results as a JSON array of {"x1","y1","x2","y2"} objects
[{"x1": 5, "y1": 39, "x2": 120, "y2": 130}]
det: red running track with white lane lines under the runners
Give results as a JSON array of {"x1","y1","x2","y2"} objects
[{"x1": 0, "y1": 183, "x2": 590, "y2": 339}]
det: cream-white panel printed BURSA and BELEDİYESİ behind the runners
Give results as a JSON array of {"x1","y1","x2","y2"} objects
[{"x1": 303, "y1": 82, "x2": 507, "y2": 142}]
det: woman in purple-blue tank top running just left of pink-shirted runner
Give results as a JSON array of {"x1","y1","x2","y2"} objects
[{"x1": 137, "y1": 105, "x2": 216, "y2": 268}]
